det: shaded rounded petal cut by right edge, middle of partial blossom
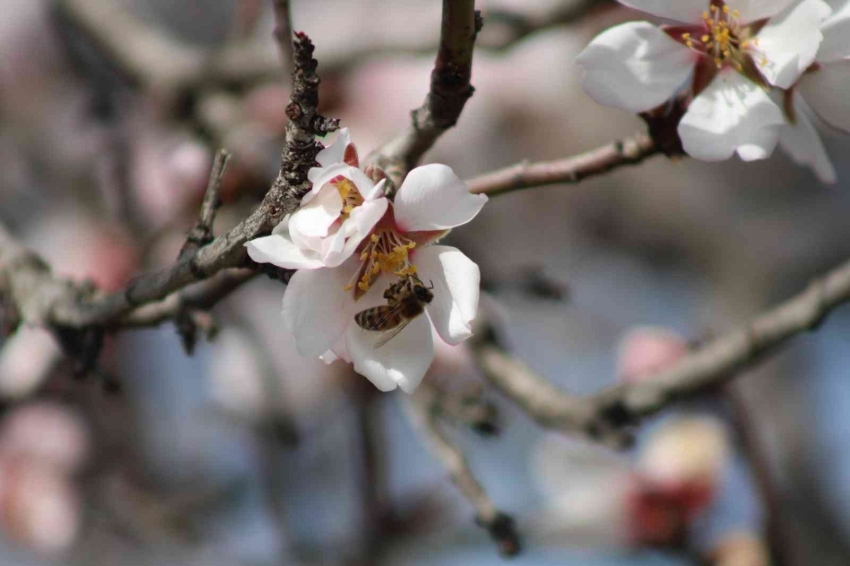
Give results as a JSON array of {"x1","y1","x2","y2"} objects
[{"x1": 797, "y1": 59, "x2": 850, "y2": 133}]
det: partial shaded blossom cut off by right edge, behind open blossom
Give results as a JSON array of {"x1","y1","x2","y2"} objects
[{"x1": 779, "y1": 0, "x2": 850, "y2": 183}]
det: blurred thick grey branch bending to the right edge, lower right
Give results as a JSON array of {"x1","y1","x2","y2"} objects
[{"x1": 472, "y1": 255, "x2": 850, "y2": 444}]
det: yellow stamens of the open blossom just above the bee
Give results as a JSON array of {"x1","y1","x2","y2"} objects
[{"x1": 345, "y1": 228, "x2": 416, "y2": 299}]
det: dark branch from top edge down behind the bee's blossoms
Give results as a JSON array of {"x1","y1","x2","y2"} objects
[{"x1": 370, "y1": 0, "x2": 483, "y2": 182}]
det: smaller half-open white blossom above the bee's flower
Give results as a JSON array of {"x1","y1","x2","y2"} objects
[{"x1": 246, "y1": 129, "x2": 389, "y2": 269}]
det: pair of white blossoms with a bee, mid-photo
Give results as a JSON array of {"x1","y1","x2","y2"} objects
[{"x1": 246, "y1": 129, "x2": 487, "y2": 393}]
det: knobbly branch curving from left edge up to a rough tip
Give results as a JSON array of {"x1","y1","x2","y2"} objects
[{"x1": 0, "y1": 33, "x2": 330, "y2": 329}]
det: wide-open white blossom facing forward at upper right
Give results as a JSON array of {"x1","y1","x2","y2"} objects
[{"x1": 577, "y1": 0, "x2": 831, "y2": 161}]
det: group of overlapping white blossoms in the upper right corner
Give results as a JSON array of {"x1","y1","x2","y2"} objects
[{"x1": 577, "y1": 0, "x2": 850, "y2": 183}]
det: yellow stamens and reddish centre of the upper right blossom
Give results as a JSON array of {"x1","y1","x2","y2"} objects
[{"x1": 680, "y1": 2, "x2": 768, "y2": 73}]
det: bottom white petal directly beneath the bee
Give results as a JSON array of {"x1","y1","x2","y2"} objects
[{"x1": 346, "y1": 314, "x2": 434, "y2": 393}]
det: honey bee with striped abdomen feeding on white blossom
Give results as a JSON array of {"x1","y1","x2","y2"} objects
[{"x1": 354, "y1": 275, "x2": 434, "y2": 349}]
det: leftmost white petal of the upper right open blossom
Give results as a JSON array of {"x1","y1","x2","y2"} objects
[{"x1": 576, "y1": 22, "x2": 698, "y2": 112}]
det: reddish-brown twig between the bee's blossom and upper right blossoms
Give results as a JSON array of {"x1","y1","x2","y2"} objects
[{"x1": 467, "y1": 134, "x2": 661, "y2": 196}]
